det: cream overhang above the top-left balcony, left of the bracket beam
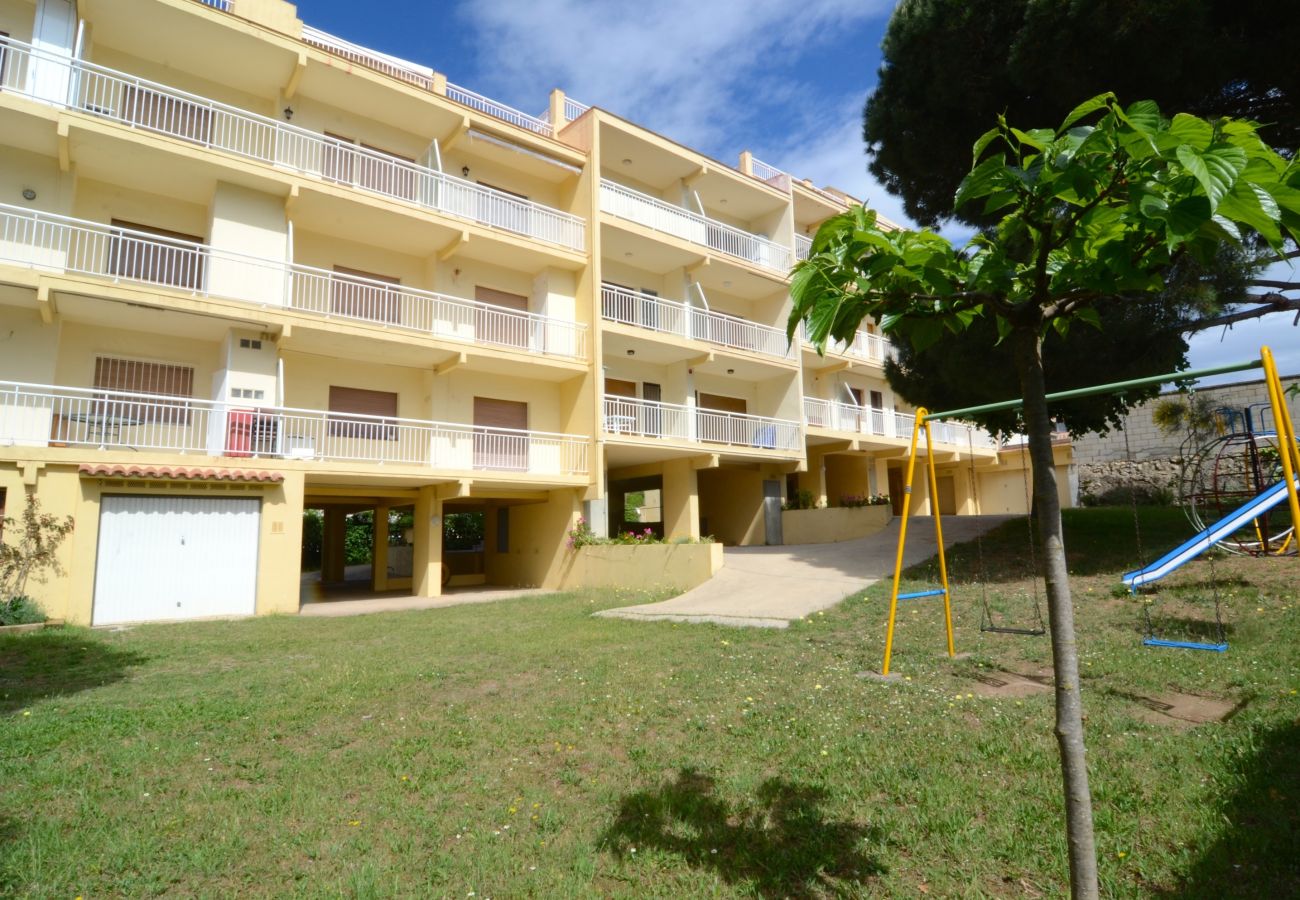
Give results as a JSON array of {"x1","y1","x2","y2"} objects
[{"x1": 78, "y1": 0, "x2": 298, "y2": 99}]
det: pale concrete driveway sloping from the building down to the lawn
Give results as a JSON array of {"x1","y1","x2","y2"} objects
[{"x1": 597, "y1": 515, "x2": 1014, "y2": 628}]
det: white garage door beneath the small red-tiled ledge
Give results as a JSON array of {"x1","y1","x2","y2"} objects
[{"x1": 91, "y1": 496, "x2": 261, "y2": 626}]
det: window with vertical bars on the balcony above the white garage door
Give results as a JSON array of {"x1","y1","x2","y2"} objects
[{"x1": 93, "y1": 356, "x2": 194, "y2": 427}]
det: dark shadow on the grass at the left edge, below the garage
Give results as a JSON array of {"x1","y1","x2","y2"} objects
[{"x1": 0, "y1": 628, "x2": 147, "y2": 713}]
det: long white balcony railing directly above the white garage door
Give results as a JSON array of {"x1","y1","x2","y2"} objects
[{"x1": 0, "y1": 381, "x2": 588, "y2": 475}]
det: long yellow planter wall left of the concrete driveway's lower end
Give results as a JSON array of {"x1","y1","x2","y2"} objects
[{"x1": 559, "y1": 544, "x2": 723, "y2": 590}]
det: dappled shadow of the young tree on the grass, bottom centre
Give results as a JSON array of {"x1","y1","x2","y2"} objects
[{"x1": 601, "y1": 767, "x2": 884, "y2": 897}]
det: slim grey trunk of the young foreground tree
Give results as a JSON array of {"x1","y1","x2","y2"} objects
[{"x1": 1015, "y1": 328, "x2": 1097, "y2": 899}]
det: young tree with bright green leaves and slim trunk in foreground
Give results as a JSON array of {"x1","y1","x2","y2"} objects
[{"x1": 788, "y1": 94, "x2": 1300, "y2": 897}]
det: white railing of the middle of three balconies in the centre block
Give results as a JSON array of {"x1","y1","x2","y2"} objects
[{"x1": 601, "y1": 284, "x2": 793, "y2": 359}]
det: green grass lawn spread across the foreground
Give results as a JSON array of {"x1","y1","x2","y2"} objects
[{"x1": 0, "y1": 510, "x2": 1300, "y2": 899}]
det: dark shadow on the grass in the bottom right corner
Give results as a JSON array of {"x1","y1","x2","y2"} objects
[{"x1": 1165, "y1": 722, "x2": 1300, "y2": 897}]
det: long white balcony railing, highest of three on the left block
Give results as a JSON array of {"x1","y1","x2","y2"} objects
[{"x1": 0, "y1": 38, "x2": 586, "y2": 251}]
